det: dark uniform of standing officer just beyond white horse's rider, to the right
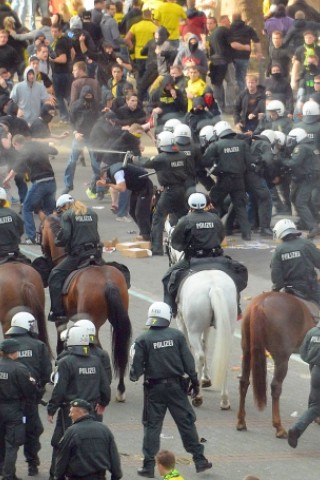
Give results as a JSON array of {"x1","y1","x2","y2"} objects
[{"x1": 202, "y1": 133, "x2": 252, "y2": 240}]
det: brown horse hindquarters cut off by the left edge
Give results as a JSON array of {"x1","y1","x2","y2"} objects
[{"x1": 0, "y1": 261, "x2": 49, "y2": 346}]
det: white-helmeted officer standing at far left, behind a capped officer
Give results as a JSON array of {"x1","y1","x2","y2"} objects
[{"x1": 5, "y1": 312, "x2": 52, "y2": 477}]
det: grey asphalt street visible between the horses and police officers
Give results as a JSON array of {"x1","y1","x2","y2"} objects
[{"x1": 3, "y1": 127, "x2": 320, "y2": 480}]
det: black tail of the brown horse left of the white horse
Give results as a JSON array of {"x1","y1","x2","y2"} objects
[{"x1": 105, "y1": 283, "x2": 132, "y2": 378}]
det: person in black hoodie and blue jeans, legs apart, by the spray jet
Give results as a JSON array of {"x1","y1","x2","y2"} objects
[{"x1": 63, "y1": 86, "x2": 100, "y2": 193}]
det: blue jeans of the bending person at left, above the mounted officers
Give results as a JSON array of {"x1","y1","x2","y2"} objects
[{"x1": 22, "y1": 180, "x2": 57, "y2": 240}]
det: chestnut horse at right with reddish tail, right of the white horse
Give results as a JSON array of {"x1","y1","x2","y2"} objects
[{"x1": 237, "y1": 292, "x2": 314, "y2": 438}]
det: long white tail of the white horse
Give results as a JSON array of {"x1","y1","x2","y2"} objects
[{"x1": 209, "y1": 286, "x2": 237, "y2": 389}]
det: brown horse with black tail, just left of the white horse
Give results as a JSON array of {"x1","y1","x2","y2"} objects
[{"x1": 40, "y1": 213, "x2": 131, "y2": 401}]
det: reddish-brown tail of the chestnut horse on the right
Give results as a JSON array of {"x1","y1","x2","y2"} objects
[{"x1": 249, "y1": 304, "x2": 267, "y2": 410}]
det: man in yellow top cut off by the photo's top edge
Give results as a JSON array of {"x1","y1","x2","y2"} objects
[{"x1": 153, "y1": 0, "x2": 187, "y2": 47}]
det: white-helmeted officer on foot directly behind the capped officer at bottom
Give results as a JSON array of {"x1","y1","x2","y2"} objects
[{"x1": 48, "y1": 326, "x2": 110, "y2": 479}]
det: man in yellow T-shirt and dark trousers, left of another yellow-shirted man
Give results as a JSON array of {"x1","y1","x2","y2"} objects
[{"x1": 124, "y1": 10, "x2": 158, "y2": 80}]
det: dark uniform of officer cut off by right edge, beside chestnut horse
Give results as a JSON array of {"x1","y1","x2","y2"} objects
[{"x1": 288, "y1": 325, "x2": 320, "y2": 448}]
